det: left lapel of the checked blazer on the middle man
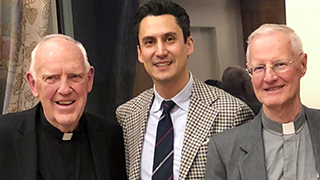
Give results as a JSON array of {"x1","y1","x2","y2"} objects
[{"x1": 127, "y1": 90, "x2": 154, "y2": 179}]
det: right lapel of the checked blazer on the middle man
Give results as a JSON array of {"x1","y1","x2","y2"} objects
[{"x1": 179, "y1": 78, "x2": 218, "y2": 179}]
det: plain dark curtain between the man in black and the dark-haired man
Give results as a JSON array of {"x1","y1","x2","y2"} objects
[{"x1": 72, "y1": 0, "x2": 139, "y2": 119}]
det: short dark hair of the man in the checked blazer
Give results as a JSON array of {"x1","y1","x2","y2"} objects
[{"x1": 134, "y1": 0, "x2": 190, "y2": 44}]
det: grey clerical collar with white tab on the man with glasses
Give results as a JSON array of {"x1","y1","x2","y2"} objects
[{"x1": 261, "y1": 108, "x2": 306, "y2": 135}]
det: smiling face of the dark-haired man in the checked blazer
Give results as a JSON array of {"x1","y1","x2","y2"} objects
[{"x1": 137, "y1": 15, "x2": 193, "y2": 91}]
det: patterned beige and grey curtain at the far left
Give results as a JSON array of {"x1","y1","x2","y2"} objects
[{"x1": 0, "y1": 0, "x2": 50, "y2": 114}]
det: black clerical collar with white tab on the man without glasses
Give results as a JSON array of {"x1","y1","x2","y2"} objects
[{"x1": 40, "y1": 108, "x2": 84, "y2": 141}]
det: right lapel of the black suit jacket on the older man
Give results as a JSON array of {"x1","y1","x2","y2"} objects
[{"x1": 85, "y1": 117, "x2": 111, "y2": 180}]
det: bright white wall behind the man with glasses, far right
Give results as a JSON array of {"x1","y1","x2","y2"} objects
[{"x1": 286, "y1": 0, "x2": 320, "y2": 108}]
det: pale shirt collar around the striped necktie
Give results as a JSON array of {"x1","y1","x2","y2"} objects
[{"x1": 150, "y1": 72, "x2": 194, "y2": 112}]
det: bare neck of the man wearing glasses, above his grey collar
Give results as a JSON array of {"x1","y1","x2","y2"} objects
[{"x1": 262, "y1": 101, "x2": 302, "y2": 124}]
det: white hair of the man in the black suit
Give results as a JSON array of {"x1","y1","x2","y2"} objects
[{"x1": 29, "y1": 34, "x2": 90, "y2": 77}]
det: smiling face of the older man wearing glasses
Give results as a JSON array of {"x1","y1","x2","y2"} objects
[{"x1": 247, "y1": 32, "x2": 307, "y2": 108}]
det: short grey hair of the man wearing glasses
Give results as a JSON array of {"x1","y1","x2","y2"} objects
[{"x1": 246, "y1": 24, "x2": 304, "y2": 62}]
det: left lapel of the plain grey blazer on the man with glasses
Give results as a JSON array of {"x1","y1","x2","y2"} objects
[{"x1": 239, "y1": 113, "x2": 267, "y2": 180}]
